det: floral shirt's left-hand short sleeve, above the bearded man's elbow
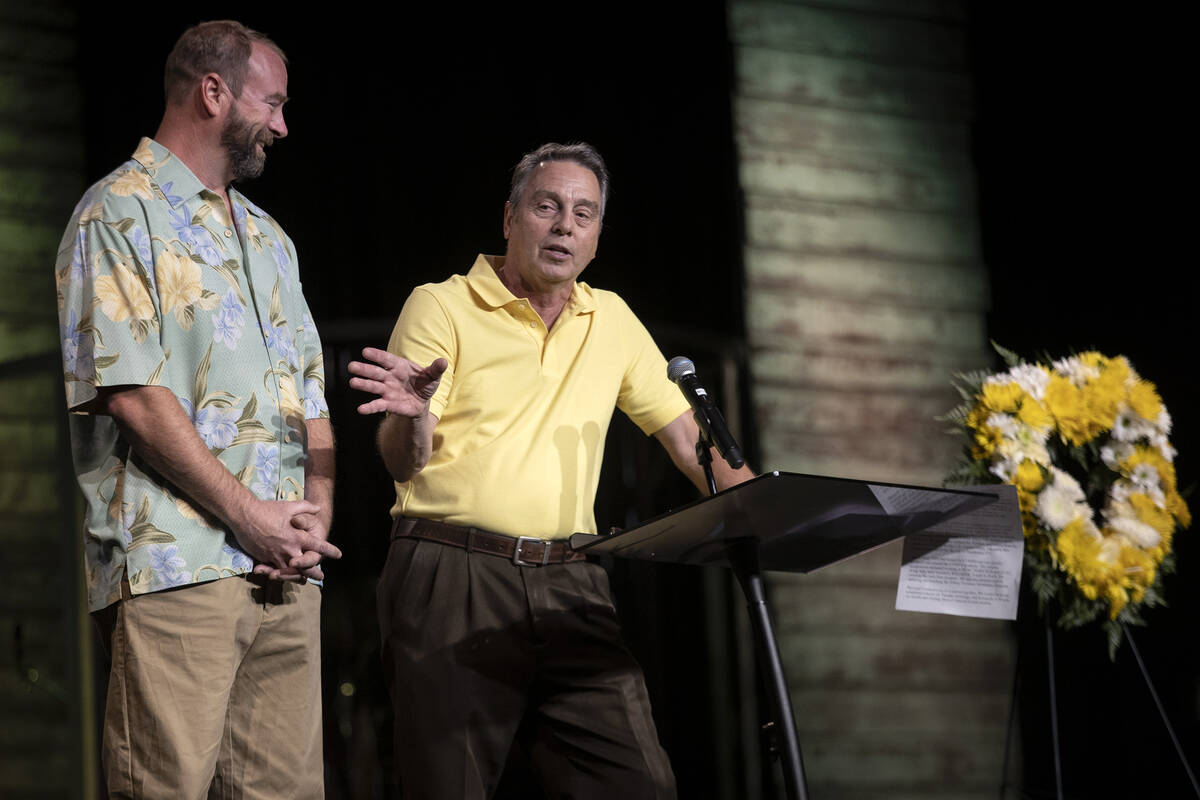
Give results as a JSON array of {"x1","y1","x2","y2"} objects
[{"x1": 56, "y1": 211, "x2": 166, "y2": 409}]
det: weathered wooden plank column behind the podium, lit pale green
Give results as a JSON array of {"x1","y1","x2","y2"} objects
[{"x1": 730, "y1": 0, "x2": 1013, "y2": 800}]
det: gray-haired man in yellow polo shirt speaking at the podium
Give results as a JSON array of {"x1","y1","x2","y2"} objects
[{"x1": 350, "y1": 144, "x2": 751, "y2": 800}]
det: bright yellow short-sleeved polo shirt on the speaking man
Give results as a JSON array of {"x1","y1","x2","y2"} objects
[{"x1": 388, "y1": 255, "x2": 689, "y2": 539}]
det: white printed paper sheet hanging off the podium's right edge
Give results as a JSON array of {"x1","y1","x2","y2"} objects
[{"x1": 896, "y1": 483, "x2": 1025, "y2": 619}]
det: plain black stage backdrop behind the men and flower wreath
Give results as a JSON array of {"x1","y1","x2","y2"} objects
[{"x1": 72, "y1": 2, "x2": 1200, "y2": 798}]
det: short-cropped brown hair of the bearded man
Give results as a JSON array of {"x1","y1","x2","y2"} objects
[{"x1": 162, "y1": 19, "x2": 288, "y2": 104}]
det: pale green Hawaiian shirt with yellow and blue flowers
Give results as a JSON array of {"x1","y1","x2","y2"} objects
[{"x1": 55, "y1": 139, "x2": 329, "y2": 610}]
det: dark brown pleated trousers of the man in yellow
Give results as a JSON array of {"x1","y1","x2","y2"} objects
[{"x1": 377, "y1": 539, "x2": 676, "y2": 800}]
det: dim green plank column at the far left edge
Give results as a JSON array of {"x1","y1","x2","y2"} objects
[{"x1": 0, "y1": 0, "x2": 95, "y2": 798}]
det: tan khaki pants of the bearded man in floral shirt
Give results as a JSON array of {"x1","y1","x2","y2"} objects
[{"x1": 96, "y1": 576, "x2": 324, "y2": 800}]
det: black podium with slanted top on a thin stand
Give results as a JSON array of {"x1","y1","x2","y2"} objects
[{"x1": 571, "y1": 473, "x2": 996, "y2": 800}]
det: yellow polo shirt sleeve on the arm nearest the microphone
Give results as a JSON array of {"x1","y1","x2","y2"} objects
[{"x1": 614, "y1": 299, "x2": 689, "y2": 435}]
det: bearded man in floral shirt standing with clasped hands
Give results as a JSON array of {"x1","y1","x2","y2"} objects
[{"x1": 56, "y1": 22, "x2": 341, "y2": 798}]
